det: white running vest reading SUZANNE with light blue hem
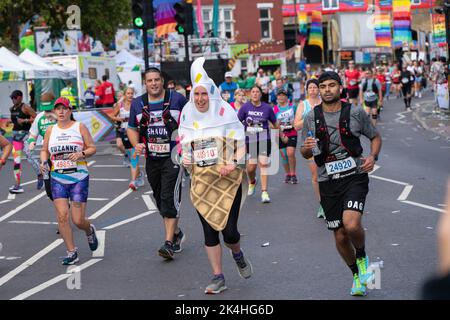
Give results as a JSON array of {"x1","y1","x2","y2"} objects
[{"x1": 48, "y1": 122, "x2": 89, "y2": 184}]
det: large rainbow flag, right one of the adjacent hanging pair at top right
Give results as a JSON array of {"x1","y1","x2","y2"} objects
[{"x1": 392, "y1": 0, "x2": 412, "y2": 47}]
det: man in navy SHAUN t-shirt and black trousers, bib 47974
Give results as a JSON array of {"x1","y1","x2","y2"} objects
[{"x1": 127, "y1": 68, "x2": 187, "y2": 260}]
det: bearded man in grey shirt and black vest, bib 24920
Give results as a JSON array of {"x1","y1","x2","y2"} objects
[{"x1": 300, "y1": 72, "x2": 381, "y2": 296}]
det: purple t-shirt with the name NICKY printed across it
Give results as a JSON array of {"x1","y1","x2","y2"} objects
[{"x1": 238, "y1": 102, "x2": 277, "y2": 142}]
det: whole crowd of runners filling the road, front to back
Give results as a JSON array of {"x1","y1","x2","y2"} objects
[{"x1": 0, "y1": 58, "x2": 442, "y2": 296}]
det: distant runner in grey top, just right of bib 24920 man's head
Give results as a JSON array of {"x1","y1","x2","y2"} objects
[{"x1": 359, "y1": 69, "x2": 383, "y2": 127}]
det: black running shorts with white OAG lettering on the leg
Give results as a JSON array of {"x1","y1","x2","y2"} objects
[{"x1": 319, "y1": 173, "x2": 369, "y2": 230}]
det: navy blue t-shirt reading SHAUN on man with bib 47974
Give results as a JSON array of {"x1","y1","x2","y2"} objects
[{"x1": 128, "y1": 91, "x2": 188, "y2": 159}]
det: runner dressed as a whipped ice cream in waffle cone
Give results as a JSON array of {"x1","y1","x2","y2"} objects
[{"x1": 180, "y1": 58, "x2": 253, "y2": 294}]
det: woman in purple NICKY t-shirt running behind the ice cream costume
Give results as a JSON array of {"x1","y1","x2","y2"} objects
[{"x1": 238, "y1": 86, "x2": 279, "y2": 203}]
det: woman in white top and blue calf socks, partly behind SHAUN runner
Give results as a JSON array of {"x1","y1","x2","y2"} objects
[{"x1": 111, "y1": 87, "x2": 144, "y2": 191}]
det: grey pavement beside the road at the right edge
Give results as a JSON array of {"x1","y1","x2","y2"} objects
[{"x1": 413, "y1": 97, "x2": 450, "y2": 140}]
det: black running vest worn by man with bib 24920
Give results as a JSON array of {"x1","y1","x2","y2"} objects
[{"x1": 314, "y1": 103, "x2": 363, "y2": 167}]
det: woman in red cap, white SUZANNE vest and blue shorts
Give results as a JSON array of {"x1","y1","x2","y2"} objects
[{"x1": 41, "y1": 97, "x2": 98, "y2": 265}]
